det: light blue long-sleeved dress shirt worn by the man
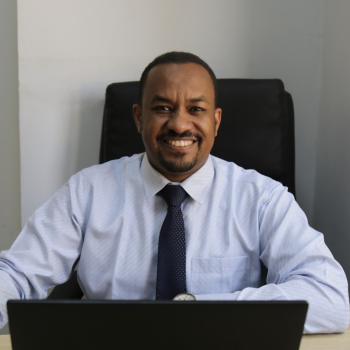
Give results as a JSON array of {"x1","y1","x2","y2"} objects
[{"x1": 0, "y1": 154, "x2": 349, "y2": 333}]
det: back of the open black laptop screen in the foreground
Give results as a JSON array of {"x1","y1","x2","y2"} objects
[{"x1": 7, "y1": 300, "x2": 308, "y2": 350}]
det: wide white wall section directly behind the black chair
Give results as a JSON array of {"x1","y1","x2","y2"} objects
[{"x1": 18, "y1": 0, "x2": 324, "y2": 222}]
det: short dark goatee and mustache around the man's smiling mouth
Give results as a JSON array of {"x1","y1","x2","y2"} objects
[{"x1": 157, "y1": 130, "x2": 203, "y2": 173}]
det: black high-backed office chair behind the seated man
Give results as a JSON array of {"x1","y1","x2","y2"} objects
[{"x1": 49, "y1": 79, "x2": 295, "y2": 299}]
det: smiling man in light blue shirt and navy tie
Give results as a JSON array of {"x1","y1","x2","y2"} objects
[{"x1": 0, "y1": 52, "x2": 349, "y2": 333}]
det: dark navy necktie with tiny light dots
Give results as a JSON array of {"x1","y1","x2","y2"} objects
[{"x1": 156, "y1": 185, "x2": 187, "y2": 300}]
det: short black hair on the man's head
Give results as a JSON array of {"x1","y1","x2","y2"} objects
[{"x1": 139, "y1": 51, "x2": 218, "y2": 107}]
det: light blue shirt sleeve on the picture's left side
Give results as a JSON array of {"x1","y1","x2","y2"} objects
[{"x1": 0, "y1": 173, "x2": 84, "y2": 328}]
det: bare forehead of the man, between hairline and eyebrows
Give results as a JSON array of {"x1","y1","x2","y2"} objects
[{"x1": 143, "y1": 63, "x2": 215, "y2": 104}]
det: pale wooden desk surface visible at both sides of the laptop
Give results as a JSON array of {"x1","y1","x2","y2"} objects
[{"x1": 0, "y1": 327, "x2": 350, "y2": 350}]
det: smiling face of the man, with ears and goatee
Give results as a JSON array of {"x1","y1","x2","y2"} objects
[{"x1": 133, "y1": 63, "x2": 221, "y2": 182}]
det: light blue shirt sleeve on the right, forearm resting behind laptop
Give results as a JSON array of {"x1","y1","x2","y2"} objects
[{"x1": 195, "y1": 186, "x2": 349, "y2": 333}]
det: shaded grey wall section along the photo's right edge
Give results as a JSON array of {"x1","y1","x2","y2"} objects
[{"x1": 314, "y1": 0, "x2": 350, "y2": 279}]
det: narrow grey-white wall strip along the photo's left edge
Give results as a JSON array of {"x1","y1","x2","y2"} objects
[{"x1": 0, "y1": 0, "x2": 21, "y2": 250}]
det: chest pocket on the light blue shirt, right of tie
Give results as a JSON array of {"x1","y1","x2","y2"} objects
[{"x1": 191, "y1": 256, "x2": 250, "y2": 294}]
